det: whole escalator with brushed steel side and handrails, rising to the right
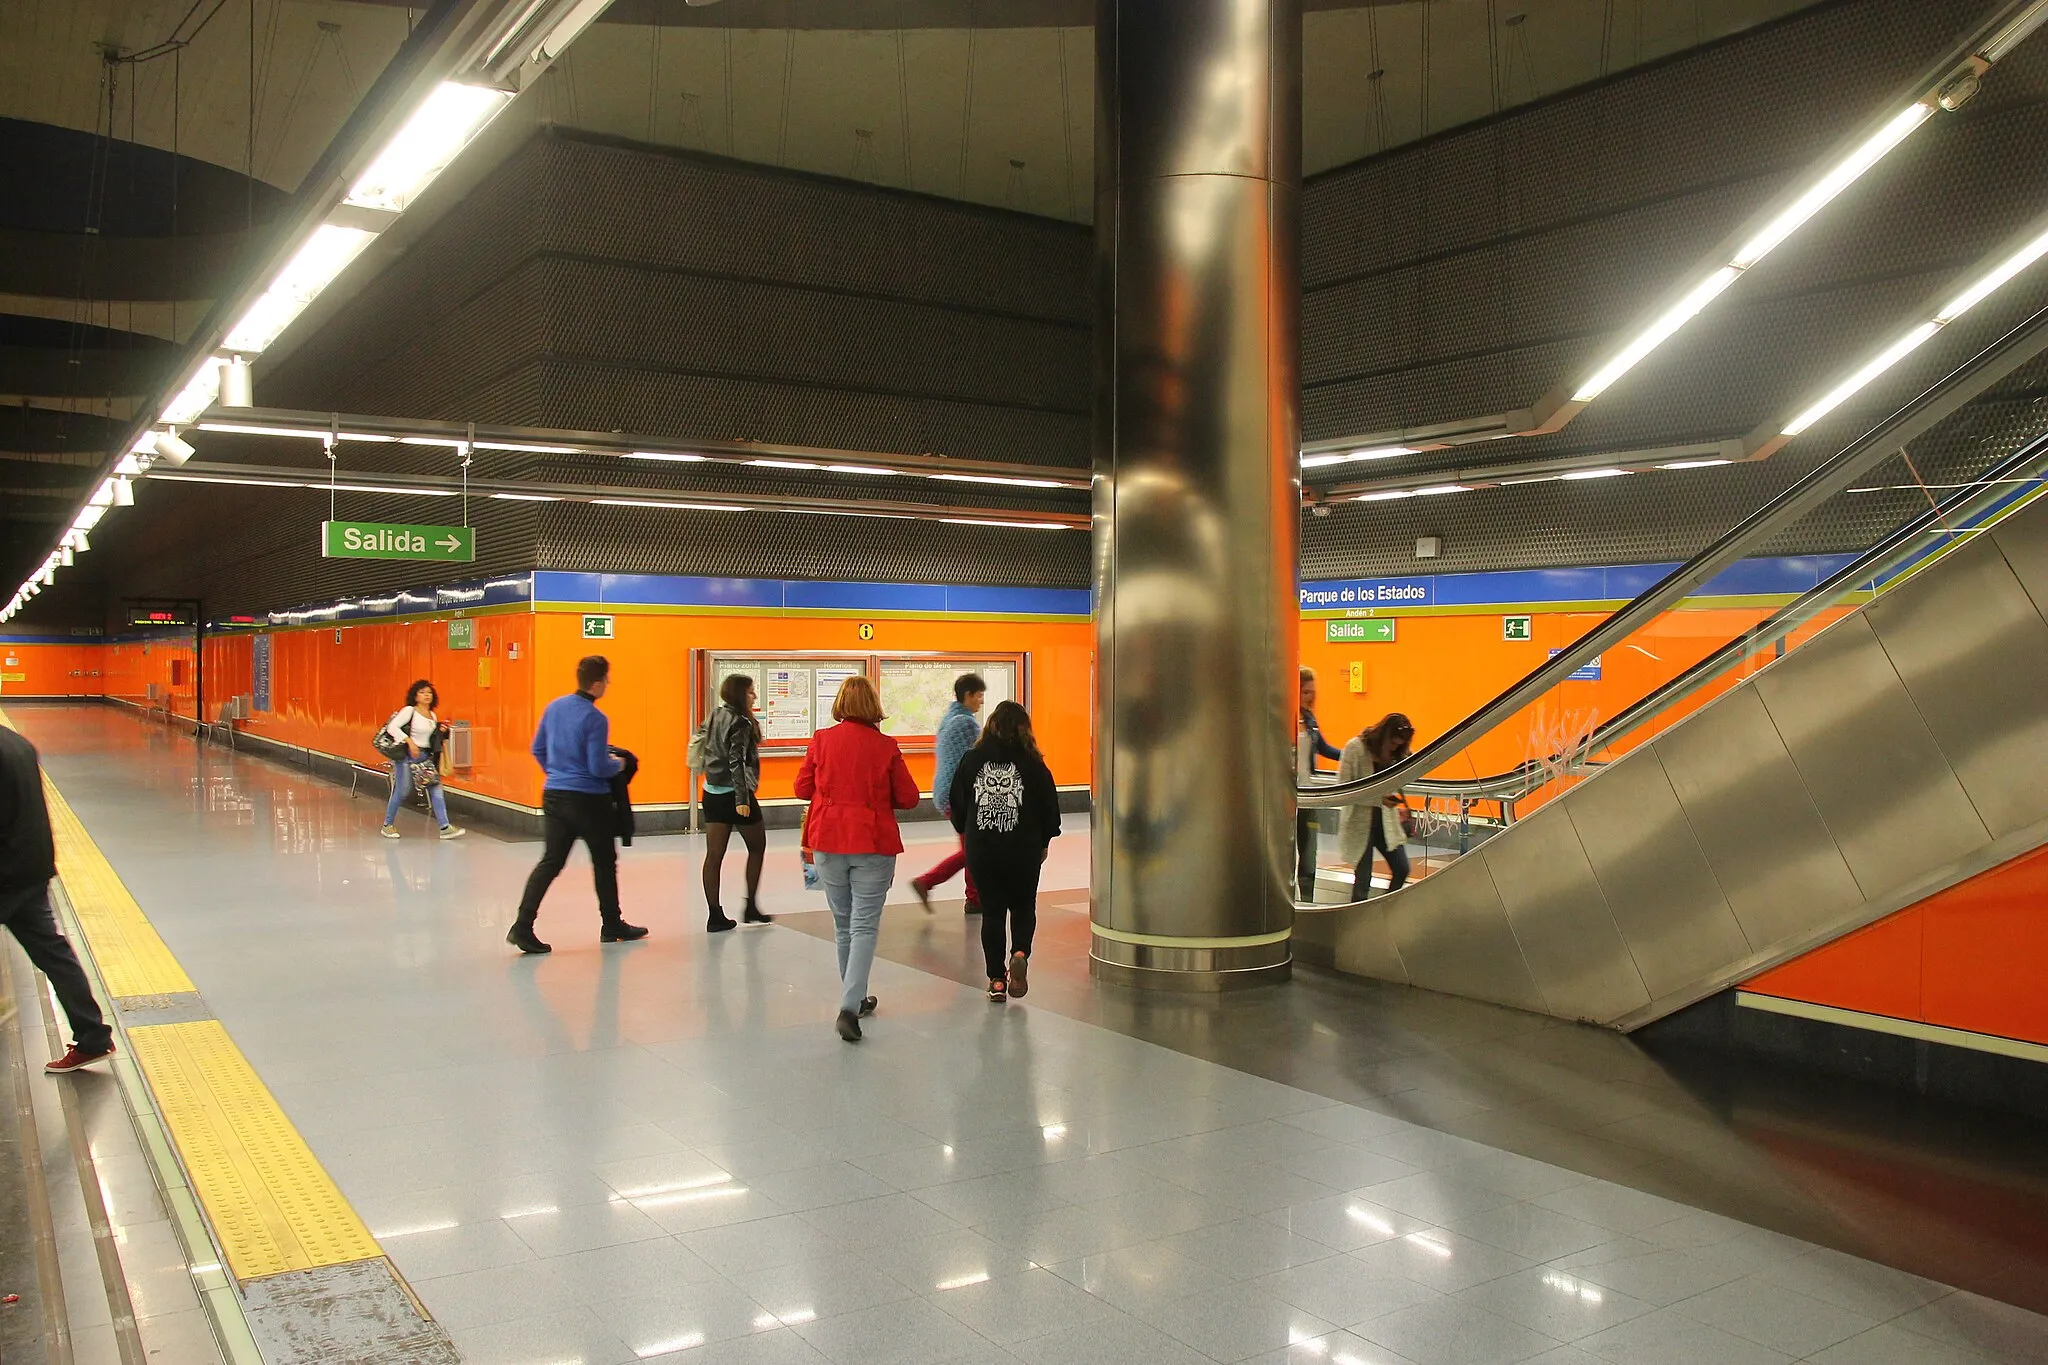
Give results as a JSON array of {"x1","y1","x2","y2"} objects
[{"x1": 1296, "y1": 300, "x2": 2048, "y2": 1029}]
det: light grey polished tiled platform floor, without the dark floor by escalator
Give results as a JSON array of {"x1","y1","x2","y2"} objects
[{"x1": 14, "y1": 710, "x2": 2048, "y2": 1365}]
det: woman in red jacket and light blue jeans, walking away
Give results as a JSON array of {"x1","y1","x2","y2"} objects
[{"x1": 797, "y1": 673, "x2": 918, "y2": 1044}]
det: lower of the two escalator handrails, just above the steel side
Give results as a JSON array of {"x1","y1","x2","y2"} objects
[{"x1": 1403, "y1": 434, "x2": 2048, "y2": 800}]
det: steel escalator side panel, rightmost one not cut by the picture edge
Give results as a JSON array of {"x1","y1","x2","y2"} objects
[{"x1": 1755, "y1": 614, "x2": 1991, "y2": 900}]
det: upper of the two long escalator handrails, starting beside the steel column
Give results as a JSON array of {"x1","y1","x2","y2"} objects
[{"x1": 1296, "y1": 307, "x2": 2048, "y2": 810}]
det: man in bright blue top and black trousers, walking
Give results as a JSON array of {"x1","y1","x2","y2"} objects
[{"x1": 506, "y1": 655, "x2": 647, "y2": 954}]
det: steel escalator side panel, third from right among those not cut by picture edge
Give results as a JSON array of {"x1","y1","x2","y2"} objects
[{"x1": 1565, "y1": 747, "x2": 1751, "y2": 999}]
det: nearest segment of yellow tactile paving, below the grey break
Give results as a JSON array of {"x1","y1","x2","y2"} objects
[{"x1": 129, "y1": 1019, "x2": 383, "y2": 1279}]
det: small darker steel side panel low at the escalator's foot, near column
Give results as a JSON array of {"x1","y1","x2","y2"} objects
[{"x1": 1368, "y1": 857, "x2": 1548, "y2": 1013}]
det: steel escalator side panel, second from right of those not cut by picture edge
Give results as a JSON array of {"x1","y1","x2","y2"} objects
[{"x1": 1651, "y1": 688, "x2": 1864, "y2": 948}]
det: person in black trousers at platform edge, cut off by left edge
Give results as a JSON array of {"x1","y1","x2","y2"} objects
[{"x1": 0, "y1": 726, "x2": 115, "y2": 1074}]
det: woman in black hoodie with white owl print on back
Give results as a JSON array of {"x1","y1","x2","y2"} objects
[{"x1": 950, "y1": 702, "x2": 1059, "y2": 1001}]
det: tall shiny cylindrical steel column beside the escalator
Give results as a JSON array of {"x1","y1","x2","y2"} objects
[{"x1": 1094, "y1": 0, "x2": 1300, "y2": 990}]
